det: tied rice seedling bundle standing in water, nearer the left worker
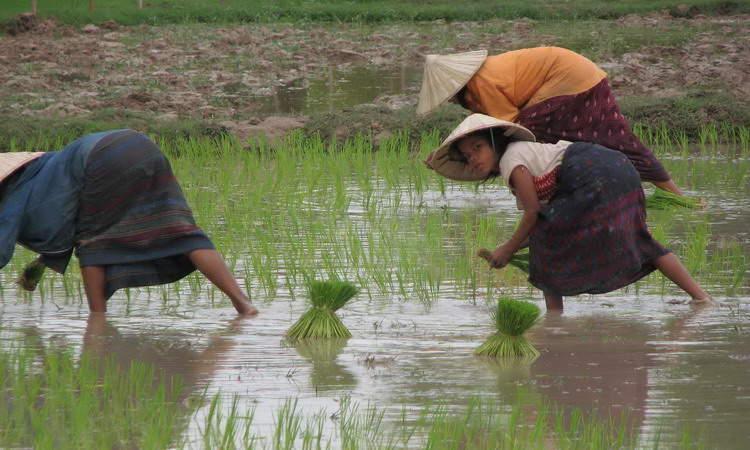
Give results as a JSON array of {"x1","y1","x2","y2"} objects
[{"x1": 286, "y1": 281, "x2": 358, "y2": 340}]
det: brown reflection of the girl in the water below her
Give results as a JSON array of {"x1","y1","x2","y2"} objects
[{"x1": 529, "y1": 308, "x2": 712, "y2": 432}]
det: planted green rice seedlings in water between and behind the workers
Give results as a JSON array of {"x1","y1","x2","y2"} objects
[{"x1": 0, "y1": 126, "x2": 750, "y2": 308}]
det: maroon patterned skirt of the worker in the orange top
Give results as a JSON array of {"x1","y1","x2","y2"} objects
[{"x1": 517, "y1": 78, "x2": 670, "y2": 181}]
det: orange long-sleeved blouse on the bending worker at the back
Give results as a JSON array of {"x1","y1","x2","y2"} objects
[{"x1": 466, "y1": 47, "x2": 607, "y2": 121}]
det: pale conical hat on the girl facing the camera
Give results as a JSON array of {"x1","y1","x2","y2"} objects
[{"x1": 424, "y1": 114, "x2": 536, "y2": 181}]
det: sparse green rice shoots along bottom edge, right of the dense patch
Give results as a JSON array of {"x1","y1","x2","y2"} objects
[{"x1": 192, "y1": 390, "x2": 705, "y2": 450}]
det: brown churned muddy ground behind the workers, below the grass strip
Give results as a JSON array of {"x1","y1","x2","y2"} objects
[{"x1": 0, "y1": 13, "x2": 750, "y2": 141}]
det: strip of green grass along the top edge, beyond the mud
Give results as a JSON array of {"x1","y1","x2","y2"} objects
[{"x1": 0, "y1": 0, "x2": 750, "y2": 25}]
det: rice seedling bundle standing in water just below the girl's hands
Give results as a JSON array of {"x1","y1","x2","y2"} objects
[{"x1": 474, "y1": 297, "x2": 541, "y2": 359}]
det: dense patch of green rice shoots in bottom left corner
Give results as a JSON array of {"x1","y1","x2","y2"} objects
[{"x1": 0, "y1": 342, "x2": 191, "y2": 449}]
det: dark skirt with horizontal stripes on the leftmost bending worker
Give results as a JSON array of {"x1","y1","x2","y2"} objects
[{"x1": 76, "y1": 130, "x2": 214, "y2": 298}]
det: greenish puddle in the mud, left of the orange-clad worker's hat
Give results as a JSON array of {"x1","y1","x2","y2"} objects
[{"x1": 255, "y1": 66, "x2": 421, "y2": 114}]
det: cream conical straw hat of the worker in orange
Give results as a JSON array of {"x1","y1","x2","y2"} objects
[{"x1": 417, "y1": 50, "x2": 487, "y2": 115}]
